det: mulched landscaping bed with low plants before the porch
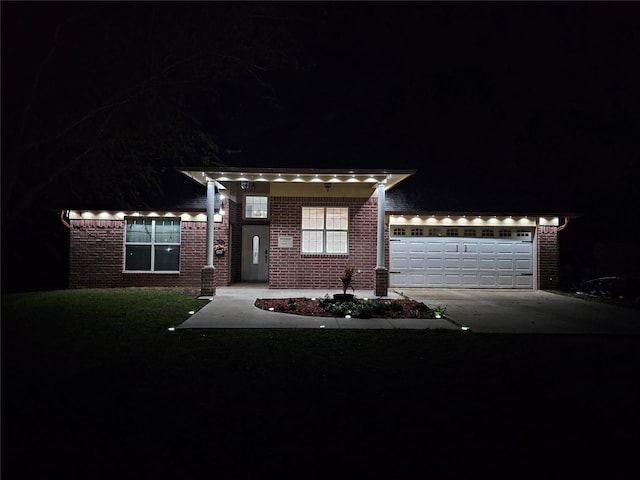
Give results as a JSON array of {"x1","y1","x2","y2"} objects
[{"x1": 255, "y1": 297, "x2": 435, "y2": 318}]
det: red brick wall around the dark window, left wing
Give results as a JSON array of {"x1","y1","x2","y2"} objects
[{"x1": 69, "y1": 220, "x2": 229, "y2": 288}]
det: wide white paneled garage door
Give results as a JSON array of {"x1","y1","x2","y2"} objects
[{"x1": 389, "y1": 230, "x2": 533, "y2": 288}]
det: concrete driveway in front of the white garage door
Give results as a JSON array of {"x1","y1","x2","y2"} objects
[{"x1": 396, "y1": 288, "x2": 640, "y2": 334}]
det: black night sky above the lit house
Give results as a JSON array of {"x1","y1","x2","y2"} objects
[{"x1": 1, "y1": 2, "x2": 640, "y2": 286}]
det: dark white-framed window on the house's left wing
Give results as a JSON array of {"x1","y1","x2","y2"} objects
[{"x1": 124, "y1": 218, "x2": 180, "y2": 272}]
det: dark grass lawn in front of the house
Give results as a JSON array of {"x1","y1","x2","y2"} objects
[{"x1": 2, "y1": 289, "x2": 640, "y2": 479}]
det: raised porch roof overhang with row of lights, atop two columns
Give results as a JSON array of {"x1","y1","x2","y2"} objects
[{"x1": 177, "y1": 167, "x2": 416, "y2": 190}]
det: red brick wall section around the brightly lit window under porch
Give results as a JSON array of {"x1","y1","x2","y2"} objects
[{"x1": 269, "y1": 197, "x2": 388, "y2": 291}]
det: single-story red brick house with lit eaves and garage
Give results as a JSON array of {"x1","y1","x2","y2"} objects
[{"x1": 68, "y1": 167, "x2": 563, "y2": 295}]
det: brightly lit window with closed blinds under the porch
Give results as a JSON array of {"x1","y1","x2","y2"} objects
[{"x1": 302, "y1": 207, "x2": 349, "y2": 253}]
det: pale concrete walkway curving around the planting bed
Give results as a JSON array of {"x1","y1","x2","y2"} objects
[{"x1": 176, "y1": 284, "x2": 460, "y2": 330}]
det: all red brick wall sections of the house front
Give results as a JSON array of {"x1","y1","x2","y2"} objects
[{"x1": 69, "y1": 208, "x2": 558, "y2": 291}]
